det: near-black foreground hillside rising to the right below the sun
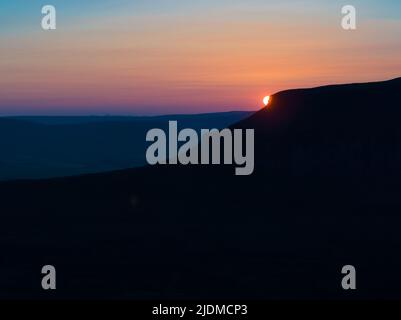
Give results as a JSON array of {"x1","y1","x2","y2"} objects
[{"x1": 0, "y1": 79, "x2": 401, "y2": 299}]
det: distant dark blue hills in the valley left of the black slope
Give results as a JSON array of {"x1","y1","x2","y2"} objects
[{"x1": 0, "y1": 112, "x2": 252, "y2": 180}]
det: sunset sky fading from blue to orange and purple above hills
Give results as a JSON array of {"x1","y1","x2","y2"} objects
[{"x1": 0, "y1": 0, "x2": 401, "y2": 115}]
